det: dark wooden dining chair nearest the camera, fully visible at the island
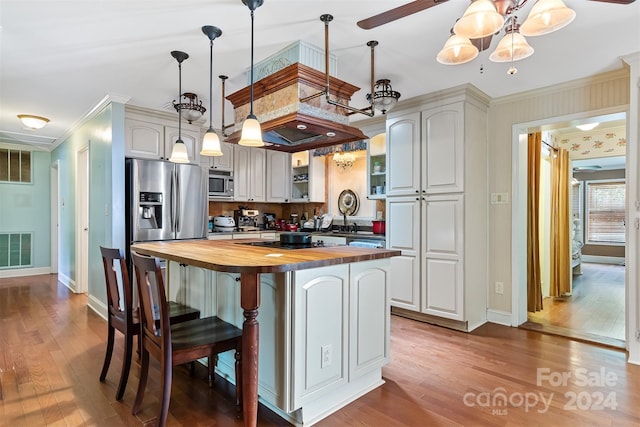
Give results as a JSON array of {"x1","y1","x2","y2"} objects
[{"x1": 131, "y1": 252, "x2": 242, "y2": 426}]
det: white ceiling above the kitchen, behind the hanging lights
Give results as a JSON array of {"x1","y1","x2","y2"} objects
[{"x1": 0, "y1": 0, "x2": 640, "y2": 150}]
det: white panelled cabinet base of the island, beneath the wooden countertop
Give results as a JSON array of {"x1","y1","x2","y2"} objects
[{"x1": 170, "y1": 258, "x2": 390, "y2": 426}]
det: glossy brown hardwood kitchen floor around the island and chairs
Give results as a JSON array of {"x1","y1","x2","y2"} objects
[{"x1": 0, "y1": 275, "x2": 640, "y2": 427}]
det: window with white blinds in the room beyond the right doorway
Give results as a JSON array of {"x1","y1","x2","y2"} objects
[{"x1": 586, "y1": 181, "x2": 626, "y2": 244}]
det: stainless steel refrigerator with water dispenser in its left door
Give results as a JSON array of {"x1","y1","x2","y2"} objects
[{"x1": 125, "y1": 158, "x2": 208, "y2": 271}]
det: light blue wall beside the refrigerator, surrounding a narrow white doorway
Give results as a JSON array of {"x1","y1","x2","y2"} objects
[{"x1": 51, "y1": 103, "x2": 125, "y2": 303}]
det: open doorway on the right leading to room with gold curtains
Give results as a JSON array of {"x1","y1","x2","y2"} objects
[{"x1": 514, "y1": 113, "x2": 628, "y2": 348}]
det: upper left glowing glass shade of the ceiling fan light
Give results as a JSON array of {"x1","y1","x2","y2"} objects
[{"x1": 453, "y1": 0, "x2": 504, "y2": 39}]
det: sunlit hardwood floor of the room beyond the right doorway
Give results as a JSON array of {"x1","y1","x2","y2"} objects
[{"x1": 524, "y1": 263, "x2": 625, "y2": 348}]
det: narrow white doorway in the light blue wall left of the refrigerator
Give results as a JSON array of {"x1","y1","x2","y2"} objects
[{"x1": 75, "y1": 146, "x2": 89, "y2": 293}]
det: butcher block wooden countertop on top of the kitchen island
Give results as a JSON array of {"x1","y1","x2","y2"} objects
[{"x1": 131, "y1": 239, "x2": 401, "y2": 273}]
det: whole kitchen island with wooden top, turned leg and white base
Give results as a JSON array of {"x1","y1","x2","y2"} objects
[{"x1": 131, "y1": 239, "x2": 400, "y2": 426}]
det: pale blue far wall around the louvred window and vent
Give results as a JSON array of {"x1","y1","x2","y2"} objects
[{"x1": 0, "y1": 143, "x2": 51, "y2": 268}]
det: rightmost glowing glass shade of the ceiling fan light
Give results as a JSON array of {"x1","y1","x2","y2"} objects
[{"x1": 520, "y1": 0, "x2": 576, "y2": 36}]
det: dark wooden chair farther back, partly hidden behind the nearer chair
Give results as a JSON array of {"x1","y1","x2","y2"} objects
[{"x1": 100, "y1": 246, "x2": 200, "y2": 400}]
